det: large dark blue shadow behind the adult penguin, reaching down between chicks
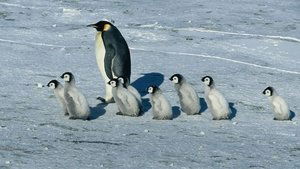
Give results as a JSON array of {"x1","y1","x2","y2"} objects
[{"x1": 131, "y1": 72, "x2": 164, "y2": 116}]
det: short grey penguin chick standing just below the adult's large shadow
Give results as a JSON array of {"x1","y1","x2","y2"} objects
[{"x1": 147, "y1": 85, "x2": 173, "y2": 120}]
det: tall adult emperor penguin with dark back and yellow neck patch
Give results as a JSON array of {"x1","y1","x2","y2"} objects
[{"x1": 88, "y1": 21, "x2": 131, "y2": 103}]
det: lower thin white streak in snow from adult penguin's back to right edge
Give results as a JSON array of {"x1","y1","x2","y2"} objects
[{"x1": 130, "y1": 48, "x2": 300, "y2": 75}]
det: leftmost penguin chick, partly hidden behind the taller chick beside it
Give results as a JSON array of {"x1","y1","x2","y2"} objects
[{"x1": 47, "y1": 80, "x2": 69, "y2": 116}]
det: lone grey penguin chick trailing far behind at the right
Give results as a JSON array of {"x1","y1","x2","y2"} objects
[{"x1": 263, "y1": 86, "x2": 291, "y2": 120}]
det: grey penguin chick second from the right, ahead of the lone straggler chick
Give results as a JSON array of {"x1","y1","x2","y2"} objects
[{"x1": 201, "y1": 76, "x2": 230, "y2": 120}]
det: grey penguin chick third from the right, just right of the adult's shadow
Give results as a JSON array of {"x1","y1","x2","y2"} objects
[{"x1": 170, "y1": 74, "x2": 200, "y2": 115}]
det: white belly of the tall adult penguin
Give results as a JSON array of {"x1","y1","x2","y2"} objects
[{"x1": 95, "y1": 32, "x2": 109, "y2": 82}]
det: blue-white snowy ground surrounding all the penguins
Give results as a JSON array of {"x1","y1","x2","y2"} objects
[{"x1": 0, "y1": 0, "x2": 300, "y2": 169}]
